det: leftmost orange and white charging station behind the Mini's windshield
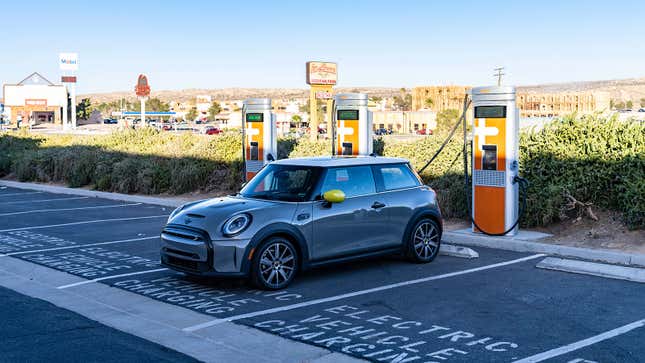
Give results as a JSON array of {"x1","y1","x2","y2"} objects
[{"x1": 242, "y1": 98, "x2": 278, "y2": 181}]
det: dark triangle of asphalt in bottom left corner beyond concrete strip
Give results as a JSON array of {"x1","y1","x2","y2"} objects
[{"x1": 0, "y1": 287, "x2": 197, "y2": 363}]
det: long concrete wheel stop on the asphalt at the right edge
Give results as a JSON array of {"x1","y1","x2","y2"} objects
[{"x1": 535, "y1": 257, "x2": 645, "y2": 283}]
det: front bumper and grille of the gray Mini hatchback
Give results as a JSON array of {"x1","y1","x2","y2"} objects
[{"x1": 160, "y1": 224, "x2": 250, "y2": 277}]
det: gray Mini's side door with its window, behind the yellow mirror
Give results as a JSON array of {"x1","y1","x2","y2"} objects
[{"x1": 313, "y1": 166, "x2": 388, "y2": 260}]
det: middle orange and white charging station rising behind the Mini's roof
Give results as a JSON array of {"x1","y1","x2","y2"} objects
[{"x1": 332, "y1": 93, "x2": 373, "y2": 155}]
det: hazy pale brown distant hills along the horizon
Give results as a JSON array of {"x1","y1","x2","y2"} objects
[{"x1": 77, "y1": 78, "x2": 645, "y2": 104}]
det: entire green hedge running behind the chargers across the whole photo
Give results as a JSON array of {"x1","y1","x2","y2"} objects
[{"x1": 0, "y1": 116, "x2": 645, "y2": 228}]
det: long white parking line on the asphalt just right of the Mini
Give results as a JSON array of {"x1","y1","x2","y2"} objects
[{"x1": 182, "y1": 254, "x2": 545, "y2": 332}]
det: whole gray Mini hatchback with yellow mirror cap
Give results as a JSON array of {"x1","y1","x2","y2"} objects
[{"x1": 161, "y1": 156, "x2": 442, "y2": 289}]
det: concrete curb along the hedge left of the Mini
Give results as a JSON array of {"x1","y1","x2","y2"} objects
[{"x1": 0, "y1": 180, "x2": 188, "y2": 207}]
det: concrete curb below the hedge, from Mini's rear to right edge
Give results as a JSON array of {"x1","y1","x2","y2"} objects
[{"x1": 443, "y1": 231, "x2": 645, "y2": 267}]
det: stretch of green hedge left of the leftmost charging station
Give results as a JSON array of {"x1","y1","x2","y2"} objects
[{"x1": 0, "y1": 129, "x2": 242, "y2": 194}]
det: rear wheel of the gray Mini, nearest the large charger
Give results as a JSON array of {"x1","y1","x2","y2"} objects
[{"x1": 406, "y1": 218, "x2": 441, "y2": 263}]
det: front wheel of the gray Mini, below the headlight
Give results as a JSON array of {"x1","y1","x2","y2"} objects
[{"x1": 251, "y1": 237, "x2": 299, "y2": 290}]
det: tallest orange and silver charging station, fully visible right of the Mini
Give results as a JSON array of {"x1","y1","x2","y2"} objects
[{"x1": 472, "y1": 86, "x2": 522, "y2": 236}]
